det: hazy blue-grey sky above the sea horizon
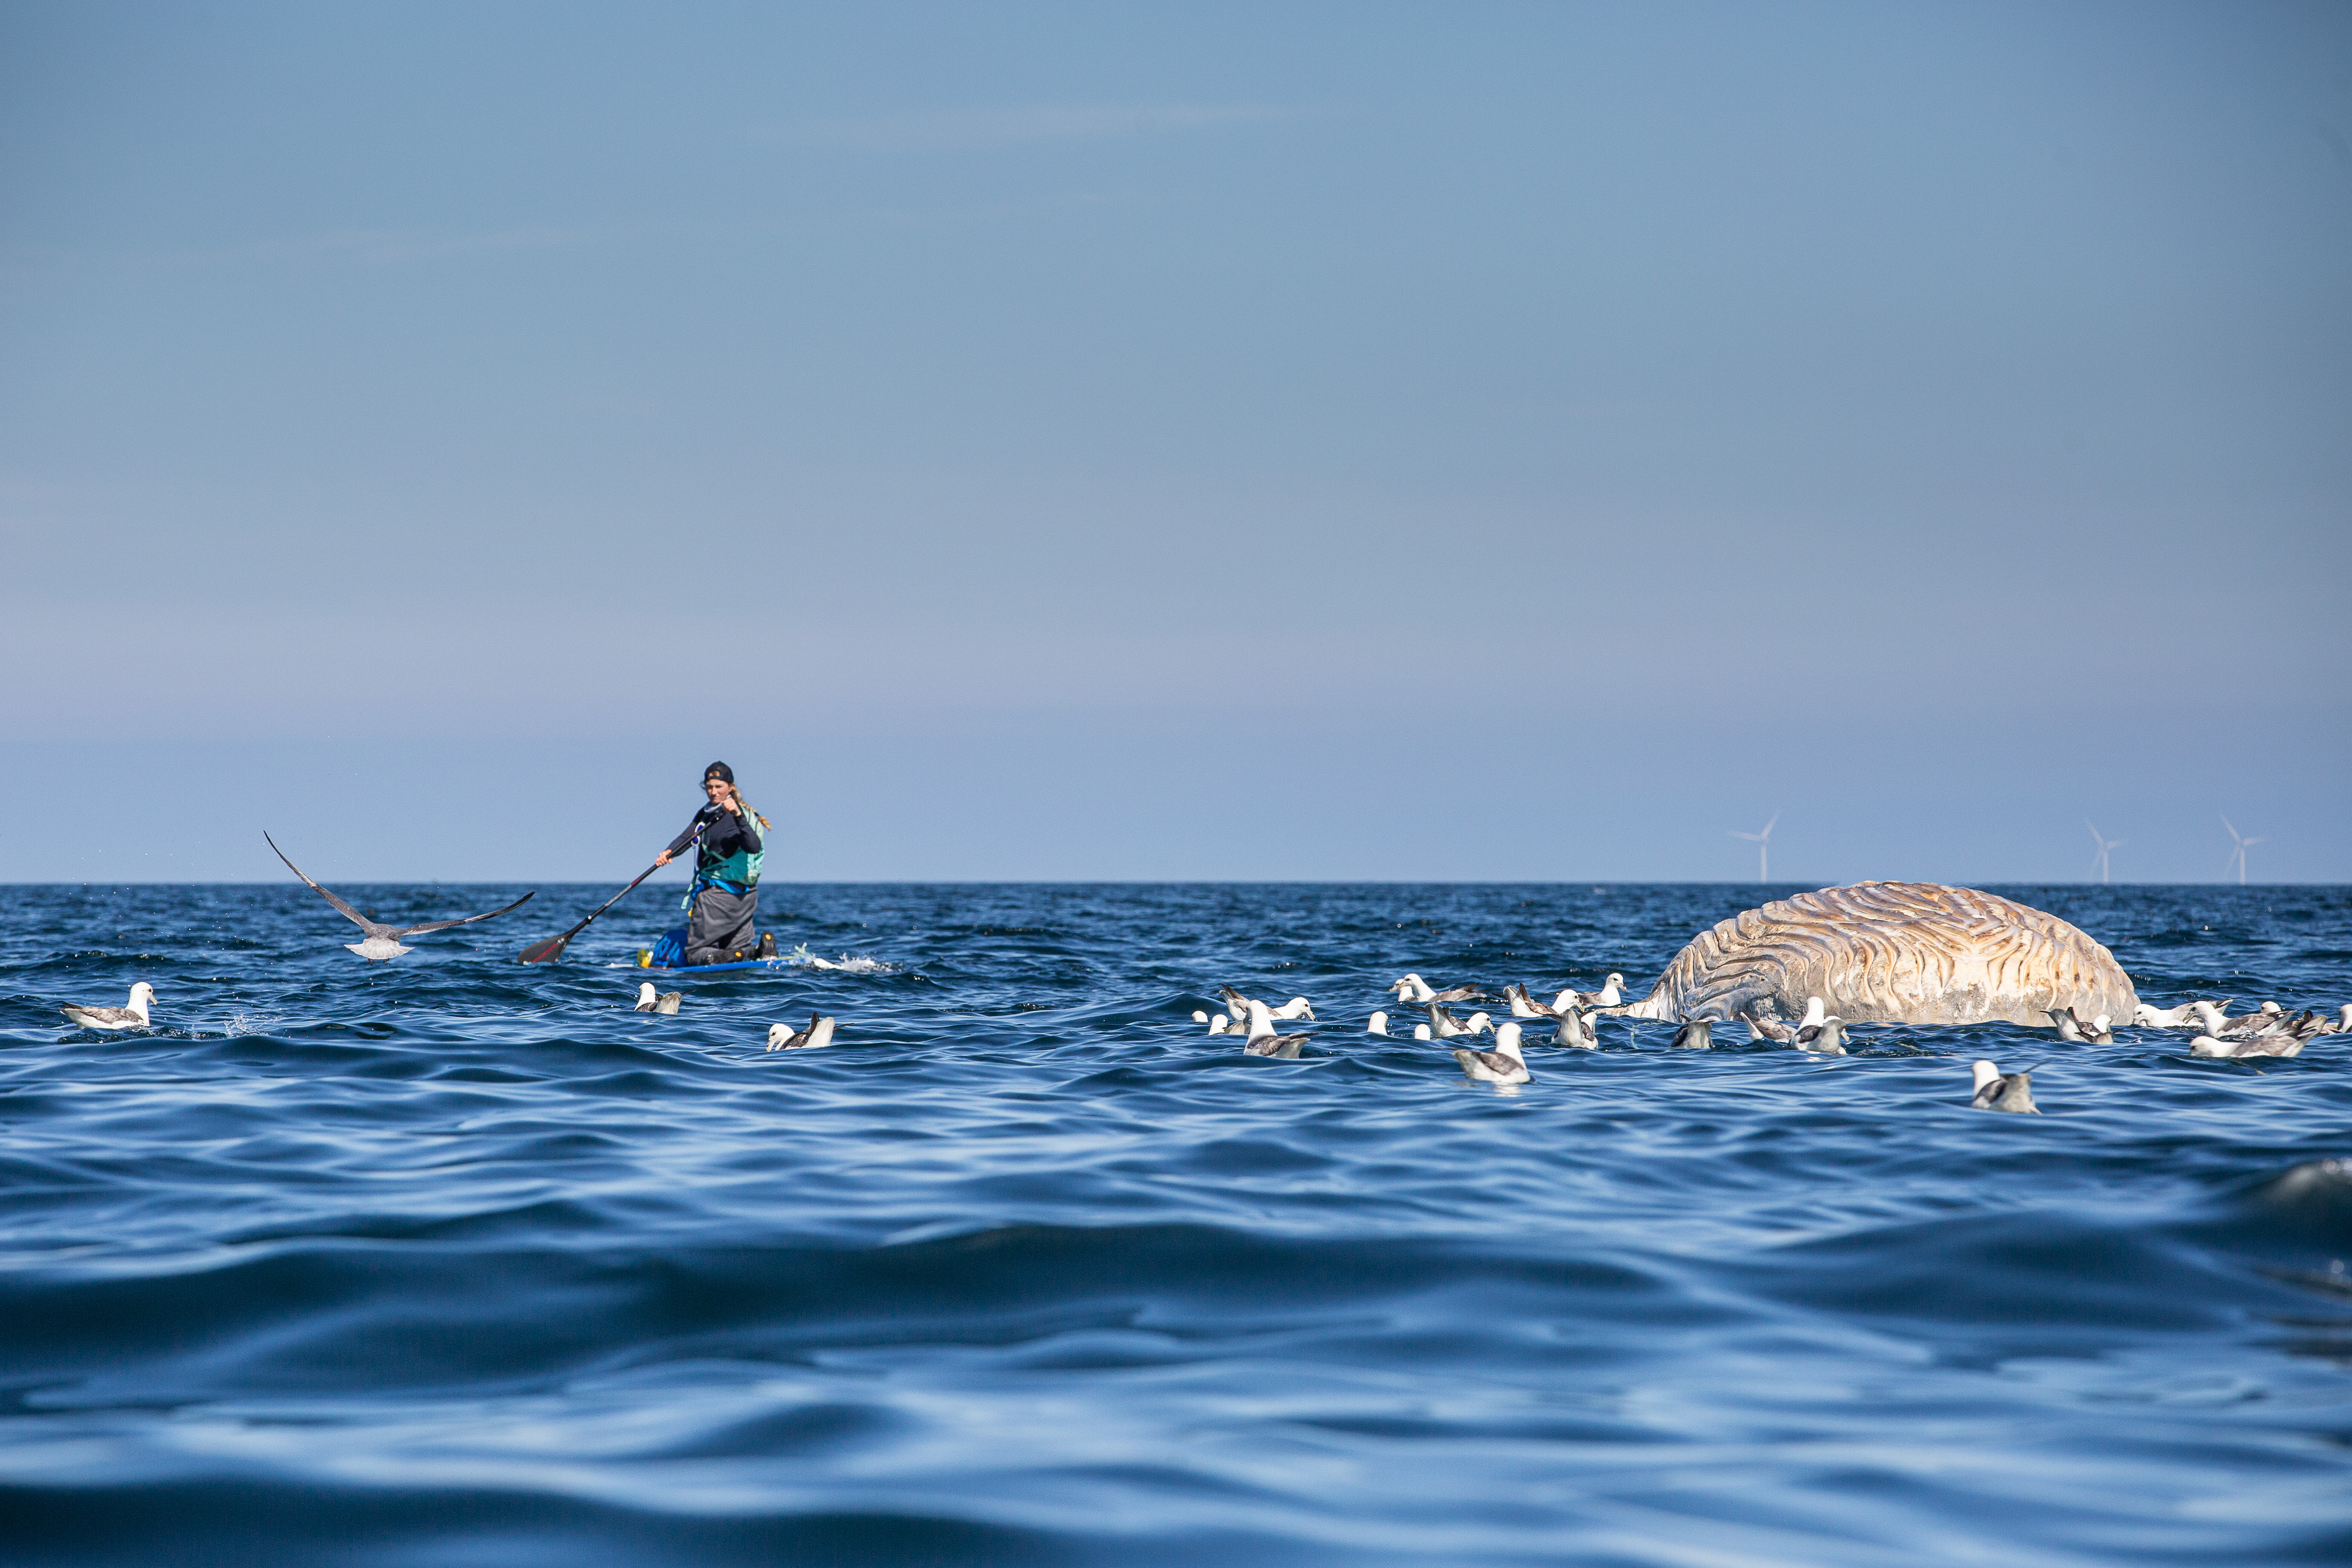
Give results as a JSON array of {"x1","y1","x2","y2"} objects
[{"x1": 0, "y1": 0, "x2": 2352, "y2": 886}]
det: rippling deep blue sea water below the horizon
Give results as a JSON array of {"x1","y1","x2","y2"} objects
[{"x1": 0, "y1": 884, "x2": 2352, "y2": 1568}]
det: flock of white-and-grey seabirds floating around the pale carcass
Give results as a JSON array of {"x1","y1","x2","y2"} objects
[{"x1": 1185, "y1": 973, "x2": 2352, "y2": 1114}]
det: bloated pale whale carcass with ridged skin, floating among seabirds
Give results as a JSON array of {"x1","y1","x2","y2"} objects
[{"x1": 1625, "y1": 881, "x2": 2138, "y2": 1030}]
